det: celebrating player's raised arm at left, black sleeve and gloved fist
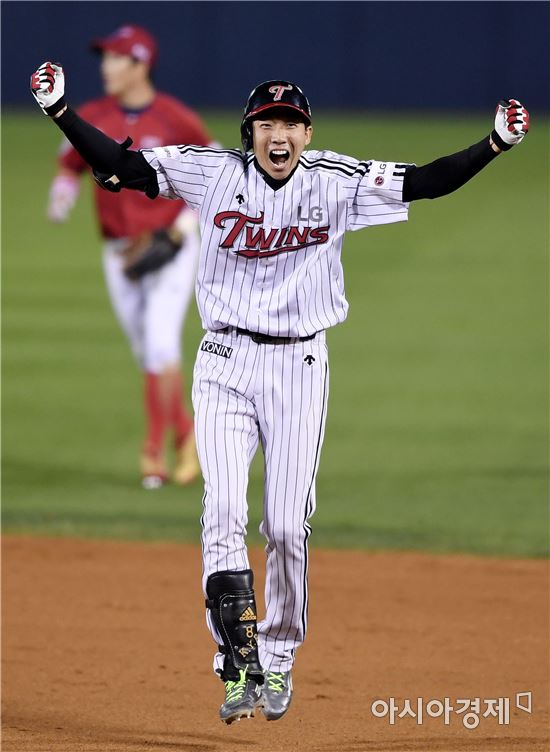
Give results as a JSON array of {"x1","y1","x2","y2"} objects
[{"x1": 31, "y1": 63, "x2": 159, "y2": 198}]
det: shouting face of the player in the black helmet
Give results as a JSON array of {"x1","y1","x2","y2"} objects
[{"x1": 252, "y1": 114, "x2": 313, "y2": 180}]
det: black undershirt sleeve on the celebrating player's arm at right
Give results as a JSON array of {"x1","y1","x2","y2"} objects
[{"x1": 403, "y1": 136, "x2": 498, "y2": 201}]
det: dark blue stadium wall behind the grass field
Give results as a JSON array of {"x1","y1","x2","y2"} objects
[{"x1": 2, "y1": 2, "x2": 550, "y2": 113}]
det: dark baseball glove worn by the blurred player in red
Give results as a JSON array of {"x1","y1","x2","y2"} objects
[{"x1": 122, "y1": 227, "x2": 183, "y2": 281}]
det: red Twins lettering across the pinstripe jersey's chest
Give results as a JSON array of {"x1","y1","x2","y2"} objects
[{"x1": 214, "y1": 211, "x2": 330, "y2": 258}]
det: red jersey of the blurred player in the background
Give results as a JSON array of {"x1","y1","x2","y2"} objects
[{"x1": 59, "y1": 93, "x2": 211, "y2": 238}]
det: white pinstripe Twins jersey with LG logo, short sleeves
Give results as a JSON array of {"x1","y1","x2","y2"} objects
[{"x1": 142, "y1": 146, "x2": 408, "y2": 337}]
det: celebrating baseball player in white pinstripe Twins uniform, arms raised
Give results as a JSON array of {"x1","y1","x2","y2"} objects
[{"x1": 31, "y1": 63, "x2": 529, "y2": 723}]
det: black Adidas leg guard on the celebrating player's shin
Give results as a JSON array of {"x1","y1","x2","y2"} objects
[{"x1": 206, "y1": 569, "x2": 264, "y2": 684}]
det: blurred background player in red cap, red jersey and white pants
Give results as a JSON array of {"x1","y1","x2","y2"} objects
[{"x1": 48, "y1": 26, "x2": 210, "y2": 488}]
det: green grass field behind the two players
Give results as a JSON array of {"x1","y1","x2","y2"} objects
[{"x1": 2, "y1": 111, "x2": 549, "y2": 556}]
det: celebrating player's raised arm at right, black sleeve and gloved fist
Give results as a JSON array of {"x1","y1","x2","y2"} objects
[{"x1": 403, "y1": 99, "x2": 529, "y2": 201}]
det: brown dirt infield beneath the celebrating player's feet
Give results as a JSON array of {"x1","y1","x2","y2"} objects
[{"x1": 2, "y1": 536, "x2": 549, "y2": 752}]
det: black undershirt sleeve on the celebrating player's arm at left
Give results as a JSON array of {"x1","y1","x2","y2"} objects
[{"x1": 53, "y1": 107, "x2": 159, "y2": 198}]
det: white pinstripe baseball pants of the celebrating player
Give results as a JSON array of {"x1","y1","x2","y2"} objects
[{"x1": 193, "y1": 332, "x2": 328, "y2": 671}]
